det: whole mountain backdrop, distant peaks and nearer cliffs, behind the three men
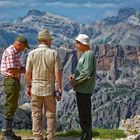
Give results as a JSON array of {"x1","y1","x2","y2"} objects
[{"x1": 0, "y1": 8, "x2": 140, "y2": 130}]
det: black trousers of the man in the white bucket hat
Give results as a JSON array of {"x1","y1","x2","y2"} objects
[{"x1": 76, "y1": 92, "x2": 92, "y2": 140}]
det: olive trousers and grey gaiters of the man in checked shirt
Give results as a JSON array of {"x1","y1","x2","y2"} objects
[{"x1": 3, "y1": 77, "x2": 21, "y2": 129}]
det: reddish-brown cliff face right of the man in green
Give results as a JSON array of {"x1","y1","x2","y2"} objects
[{"x1": 95, "y1": 45, "x2": 140, "y2": 70}]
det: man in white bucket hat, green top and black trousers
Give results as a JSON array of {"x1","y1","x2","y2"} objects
[{"x1": 69, "y1": 34, "x2": 96, "y2": 140}]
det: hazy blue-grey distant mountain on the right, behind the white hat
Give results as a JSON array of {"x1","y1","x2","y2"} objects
[{"x1": 80, "y1": 8, "x2": 140, "y2": 47}]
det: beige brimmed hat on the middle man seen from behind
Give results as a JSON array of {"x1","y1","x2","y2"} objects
[{"x1": 37, "y1": 30, "x2": 52, "y2": 40}]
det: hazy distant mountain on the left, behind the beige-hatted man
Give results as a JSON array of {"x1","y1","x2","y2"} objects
[{"x1": 0, "y1": 10, "x2": 79, "y2": 46}]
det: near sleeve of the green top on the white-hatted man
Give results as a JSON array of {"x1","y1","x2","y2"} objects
[{"x1": 73, "y1": 55, "x2": 96, "y2": 85}]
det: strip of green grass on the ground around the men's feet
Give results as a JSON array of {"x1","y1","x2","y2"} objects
[{"x1": 0, "y1": 128, "x2": 126, "y2": 139}]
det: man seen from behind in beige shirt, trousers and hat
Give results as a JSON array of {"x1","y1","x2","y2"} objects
[{"x1": 26, "y1": 30, "x2": 62, "y2": 140}]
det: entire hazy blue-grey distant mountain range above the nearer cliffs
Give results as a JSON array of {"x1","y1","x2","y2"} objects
[{"x1": 0, "y1": 8, "x2": 140, "y2": 47}]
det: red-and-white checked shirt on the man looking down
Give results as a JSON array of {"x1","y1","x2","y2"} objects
[{"x1": 1, "y1": 45, "x2": 21, "y2": 78}]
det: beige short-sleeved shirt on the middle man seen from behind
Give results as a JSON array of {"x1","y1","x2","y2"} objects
[{"x1": 26, "y1": 44, "x2": 62, "y2": 96}]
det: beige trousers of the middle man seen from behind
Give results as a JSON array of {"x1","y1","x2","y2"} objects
[{"x1": 31, "y1": 95, "x2": 56, "y2": 140}]
